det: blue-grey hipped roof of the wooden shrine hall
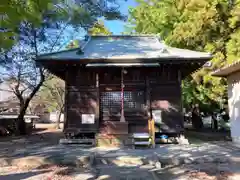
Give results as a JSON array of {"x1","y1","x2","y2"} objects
[{"x1": 38, "y1": 35, "x2": 212, "y2": 60}]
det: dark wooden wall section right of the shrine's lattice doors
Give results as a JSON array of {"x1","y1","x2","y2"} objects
[{"x1": 149, "y1": 66, "x2": 184, "y2": 133}]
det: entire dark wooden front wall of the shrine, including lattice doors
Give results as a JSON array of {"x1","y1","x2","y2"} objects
[{"x1": 65, "y1": 66, "x2": 183, "y2": 133}]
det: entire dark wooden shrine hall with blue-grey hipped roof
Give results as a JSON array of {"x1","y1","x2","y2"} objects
[{"x1": 36, "y1": 35, "x2": 212, "y2": 144}]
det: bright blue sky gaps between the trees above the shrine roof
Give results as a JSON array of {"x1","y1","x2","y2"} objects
[{"x1": 104, "y1": 0, "x2": 137, "y2": 34}]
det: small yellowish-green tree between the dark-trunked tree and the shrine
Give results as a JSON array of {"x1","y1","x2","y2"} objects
[{"x1": 38, "y1": 76, "x2": 65, "y2": 129}]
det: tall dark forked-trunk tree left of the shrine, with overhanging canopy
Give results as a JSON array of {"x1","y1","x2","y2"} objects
[{"x1": 1, "y1": 0, "x2": 126, "y2": 134}]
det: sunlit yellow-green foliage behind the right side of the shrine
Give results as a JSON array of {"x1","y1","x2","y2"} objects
[{"x1": 128, "y1": 0, "x2": 240, "y2": 111}]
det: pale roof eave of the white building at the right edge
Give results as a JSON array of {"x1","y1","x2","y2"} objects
[{"x1": 212, "y1": 60, "x2": 240, "y2": 77}]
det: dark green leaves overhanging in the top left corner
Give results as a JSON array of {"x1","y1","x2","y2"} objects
[{"x1": 0, "y1": 0, "x2": 53, "y2": 49}]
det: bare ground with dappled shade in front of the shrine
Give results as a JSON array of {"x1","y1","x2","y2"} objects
[{"x1": 0, "y1": 124, "x2": 240, "y2": 180}]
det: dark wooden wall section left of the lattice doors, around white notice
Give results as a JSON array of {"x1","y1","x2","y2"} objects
[{"x1": 65, "y1": 67, "x2": 99, "y2": 133}]
